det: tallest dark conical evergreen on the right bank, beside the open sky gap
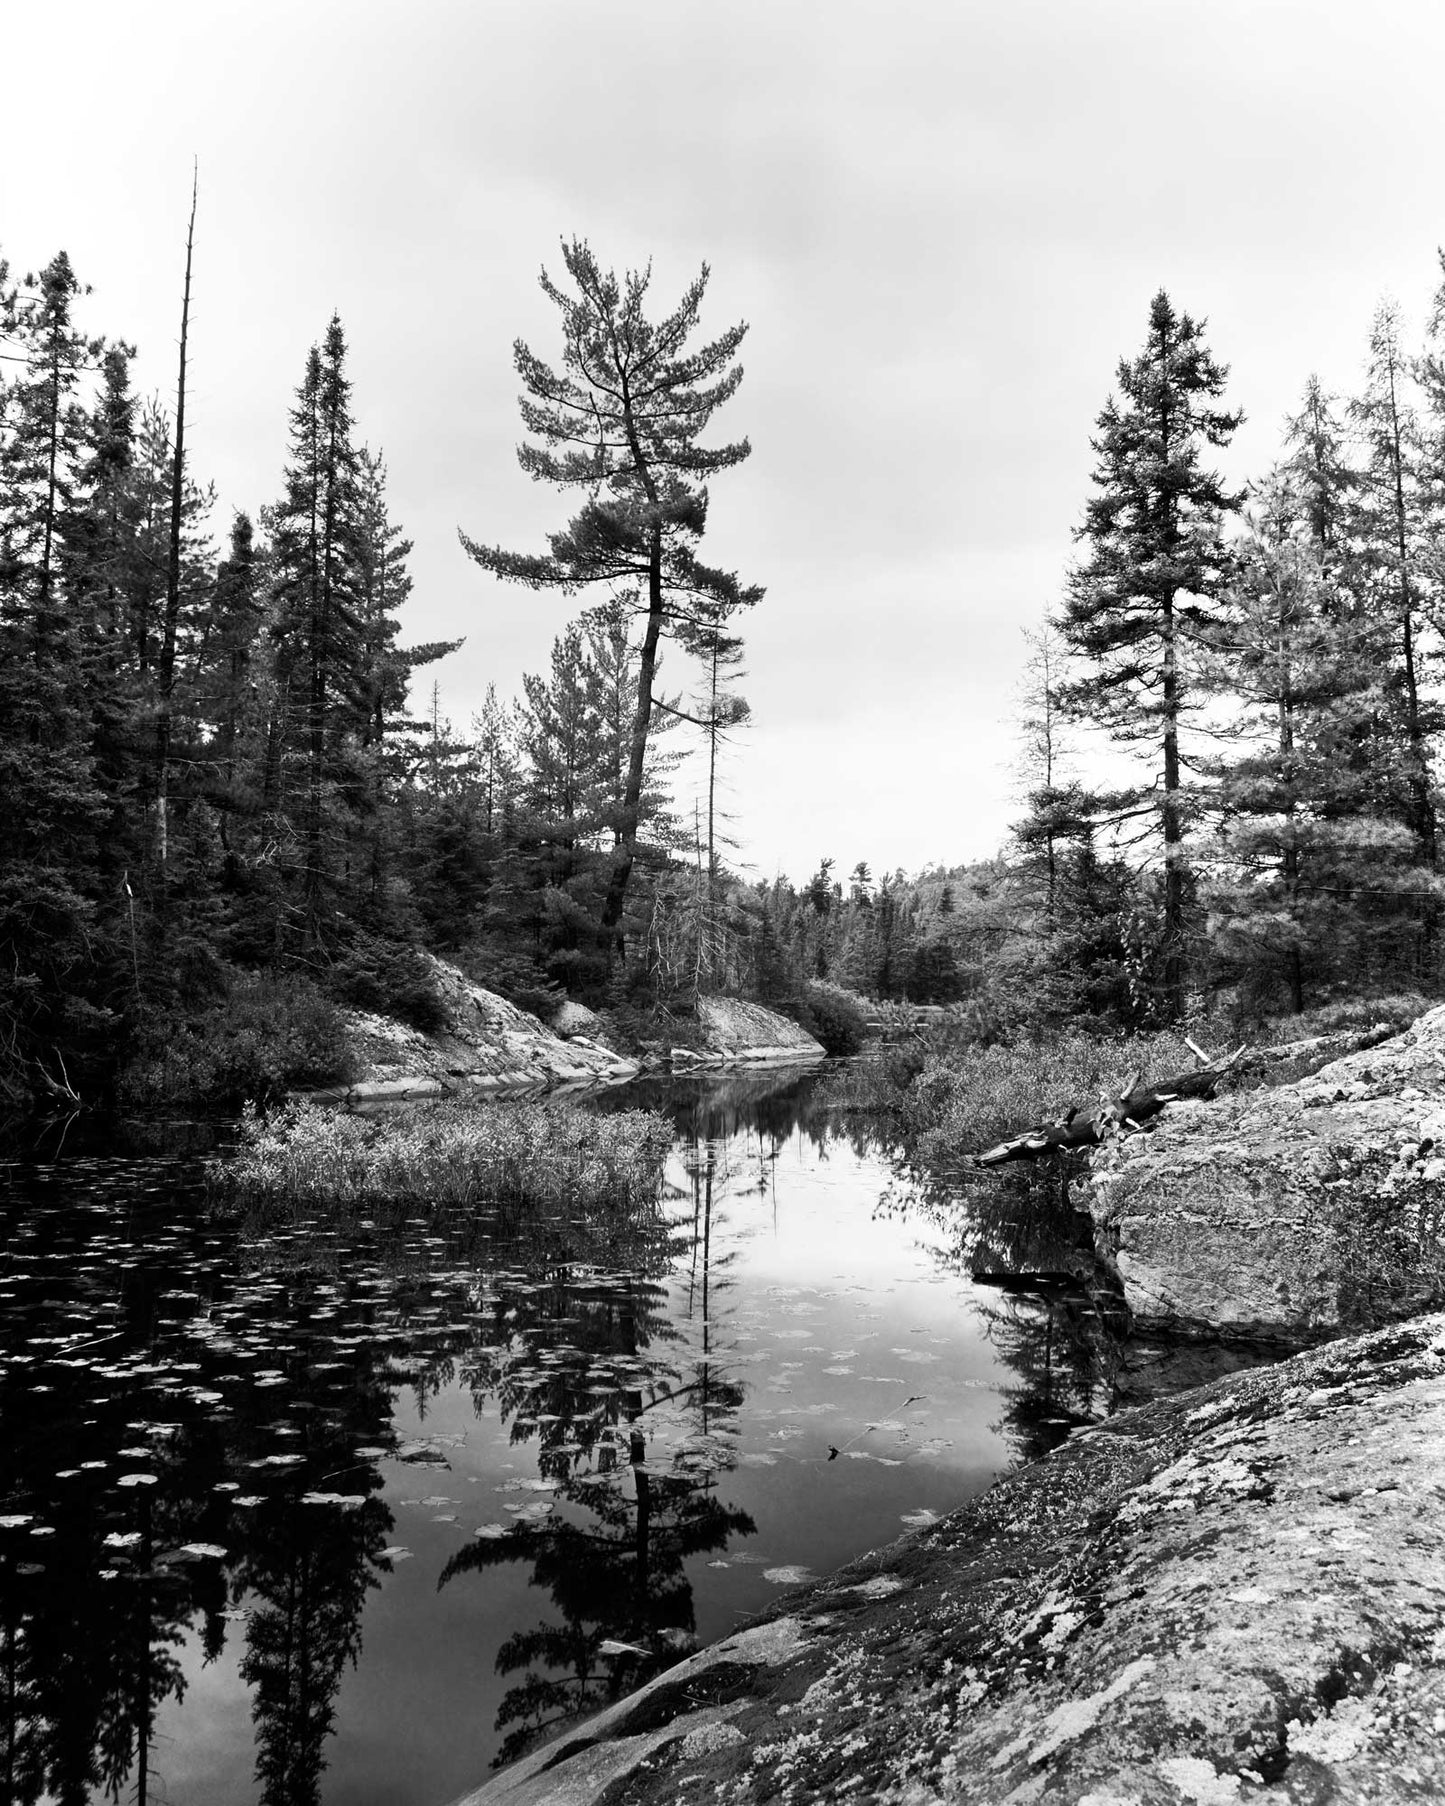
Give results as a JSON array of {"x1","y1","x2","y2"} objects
[{"x1": 1057, "y1": 291, "x2": 1243, "y2": 1020}]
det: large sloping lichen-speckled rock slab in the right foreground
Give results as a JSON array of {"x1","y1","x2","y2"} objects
[{"x1": 446, "y1": 1315, "x2": 1445, "y2": 1806}]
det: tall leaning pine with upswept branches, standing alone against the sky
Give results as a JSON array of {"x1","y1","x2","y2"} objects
[{"x1": 461, "y1": 240, "x2": 762, "y2": 943}]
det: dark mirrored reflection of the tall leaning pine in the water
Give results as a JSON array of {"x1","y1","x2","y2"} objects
[{"x1": 439, "y1": 1132, "x2": 755, "y2": 1764}]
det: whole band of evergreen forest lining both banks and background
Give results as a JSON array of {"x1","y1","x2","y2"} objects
[{"x1": 0, "y1": 229, "x2": 1445, "y2": 1116}]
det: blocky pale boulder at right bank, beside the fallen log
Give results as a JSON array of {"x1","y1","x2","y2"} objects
[{"x1": 1075, "y1": 1006, "x2": 1445, "y2": 1345}]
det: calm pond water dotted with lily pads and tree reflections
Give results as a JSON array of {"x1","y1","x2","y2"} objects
[{"x1": 0, "y1": 1075, "x2": 1093, "y2": 1806}]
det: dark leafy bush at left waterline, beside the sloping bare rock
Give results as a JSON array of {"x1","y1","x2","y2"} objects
[{"x1": 119, "y1": 972, "x2": 350, "y2": 1109}]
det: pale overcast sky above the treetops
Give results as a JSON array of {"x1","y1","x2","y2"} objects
[{"x1": 0, "y1": 0, "x2": 1445, "y2": 878}]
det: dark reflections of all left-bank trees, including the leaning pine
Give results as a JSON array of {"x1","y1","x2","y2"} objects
[{"x1": 0, "y1": 1119, "x2": 780, "y2": 1784}]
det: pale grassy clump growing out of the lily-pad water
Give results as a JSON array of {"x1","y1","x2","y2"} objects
[{"x1": 210, "y1": 1102, "x2": 672, "y2": 1212}]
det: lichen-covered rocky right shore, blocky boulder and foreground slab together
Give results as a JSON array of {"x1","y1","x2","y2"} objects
[{"x1": 446, "y1": 1008, "x2": 1445, "y2": 1806}]
